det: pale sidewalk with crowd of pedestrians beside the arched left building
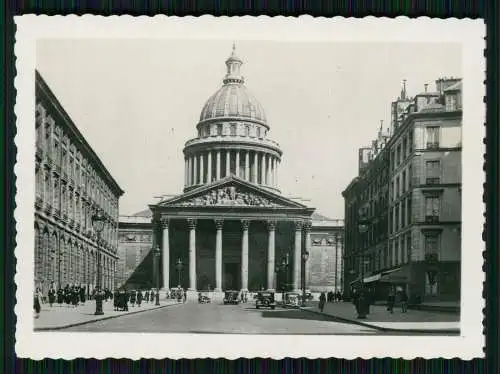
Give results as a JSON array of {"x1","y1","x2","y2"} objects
[{"x1": 34, "y1": 300, "x2": 179, "y2": 331}]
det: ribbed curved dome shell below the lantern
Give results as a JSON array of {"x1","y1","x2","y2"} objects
[{"x1": 200, "y1": 83, "x2": 266, "y2": 124}]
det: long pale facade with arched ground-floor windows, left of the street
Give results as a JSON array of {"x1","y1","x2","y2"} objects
[{"x1": 34, "y1": 72, "x2": 123, "y2": 293}]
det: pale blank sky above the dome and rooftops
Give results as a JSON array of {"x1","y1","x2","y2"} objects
[{"x1": 37, "y1": 39, "x2": 462, "y2": 219}]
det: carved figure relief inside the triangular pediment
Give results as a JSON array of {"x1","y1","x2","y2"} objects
[{"x1": 178, "y1": 186, "x2": 280, "y2": 207}]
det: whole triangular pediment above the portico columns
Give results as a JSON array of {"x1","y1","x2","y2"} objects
[{"x1": 158, "y1": 176, "x2": 308, "y2": 209}]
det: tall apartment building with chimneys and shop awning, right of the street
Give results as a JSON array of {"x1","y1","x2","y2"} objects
[{"x1": 343, "y1": 78, "x2": 462, "y2": 301}]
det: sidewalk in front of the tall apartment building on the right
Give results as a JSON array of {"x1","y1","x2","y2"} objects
[{"x1": 301, "y1": 302, "x2": 460, "y2": 334}]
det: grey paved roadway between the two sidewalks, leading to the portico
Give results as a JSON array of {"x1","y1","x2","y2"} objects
[{"x1": 63, "y1": 302, "x2": 378, "y2": 334}]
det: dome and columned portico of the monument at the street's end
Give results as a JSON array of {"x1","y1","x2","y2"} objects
[{"x1": 143, "y1": 45, "x2": 342, "y2": 296}]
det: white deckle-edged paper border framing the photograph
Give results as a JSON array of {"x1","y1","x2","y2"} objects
[{"x1": 15, "y1": 15, "x2": 485, "y2": 359}]
